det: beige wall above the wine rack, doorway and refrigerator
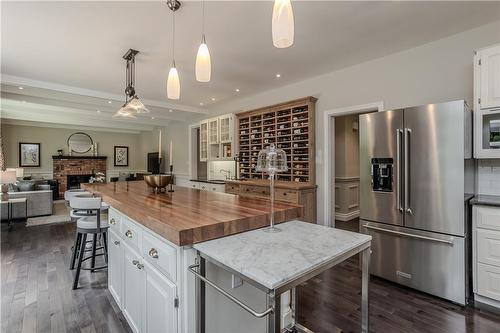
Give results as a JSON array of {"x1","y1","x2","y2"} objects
[{"x1": 204, "y1": 21, "x2": 500, "y2": 224}]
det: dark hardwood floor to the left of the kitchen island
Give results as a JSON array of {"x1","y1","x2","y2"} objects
[{"x1": 1, "y1": 223, "x2": 131, "y2": 333}]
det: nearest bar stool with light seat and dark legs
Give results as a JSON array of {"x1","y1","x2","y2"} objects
[{"x1": 70, "y1": 196, "x2": 108, "y2": 290}]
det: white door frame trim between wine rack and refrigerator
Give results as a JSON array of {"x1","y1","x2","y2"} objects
[{"x1": 323, "y1": 101, "x2": 384, "y2": 227}]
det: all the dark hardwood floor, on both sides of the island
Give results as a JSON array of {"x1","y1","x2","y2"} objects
[{"x1": 1, "y1": 219, "x2": 500, "y2": 333}]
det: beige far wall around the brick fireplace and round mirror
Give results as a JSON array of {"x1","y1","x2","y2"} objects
[{"x1": 1, "y1": 124, "x2": 166, "y2": 174}]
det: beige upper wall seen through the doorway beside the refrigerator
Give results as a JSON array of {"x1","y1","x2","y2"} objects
[{"x1": 335, "y1": 115, "x2": 359, "y2": 178}]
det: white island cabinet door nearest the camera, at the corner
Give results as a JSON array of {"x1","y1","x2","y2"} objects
[{"x1": 143, "y1": 262, "x2": 178, "y2": 333}]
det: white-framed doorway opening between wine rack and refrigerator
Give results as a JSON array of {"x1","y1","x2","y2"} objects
[{"x1": 323, "y1": 102, "x2": 384, "y2": 230}]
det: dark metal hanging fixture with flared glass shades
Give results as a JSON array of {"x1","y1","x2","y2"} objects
[{"x1": 113, "y1": 49, "x2": 149, "y2": 119}]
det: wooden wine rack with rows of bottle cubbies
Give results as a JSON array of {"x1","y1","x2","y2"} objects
[{"x1": 237, "y1": 97, "x2": 317, "y2": 184}]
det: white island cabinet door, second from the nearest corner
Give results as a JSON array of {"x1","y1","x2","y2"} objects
[{"x1": 122, "y1": 242, "x2": 145, "y2": 333}]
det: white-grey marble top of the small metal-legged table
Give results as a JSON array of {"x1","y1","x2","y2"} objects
[{"x1": 193, "y1": 221, "x2": 372, "y2": 289}]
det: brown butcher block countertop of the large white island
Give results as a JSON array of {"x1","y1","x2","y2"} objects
[{"x1": 82, "y1": 181, "x2": 303, "y2": 246}]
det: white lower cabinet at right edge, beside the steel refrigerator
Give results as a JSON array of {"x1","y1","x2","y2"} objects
[{"x1": 472, "y1": 205, "x2": 500, "y2": 308}]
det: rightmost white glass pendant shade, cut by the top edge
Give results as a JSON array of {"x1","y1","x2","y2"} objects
[{"x1": 272, "y1": 0, "x2": 295, "y2": 49}]
